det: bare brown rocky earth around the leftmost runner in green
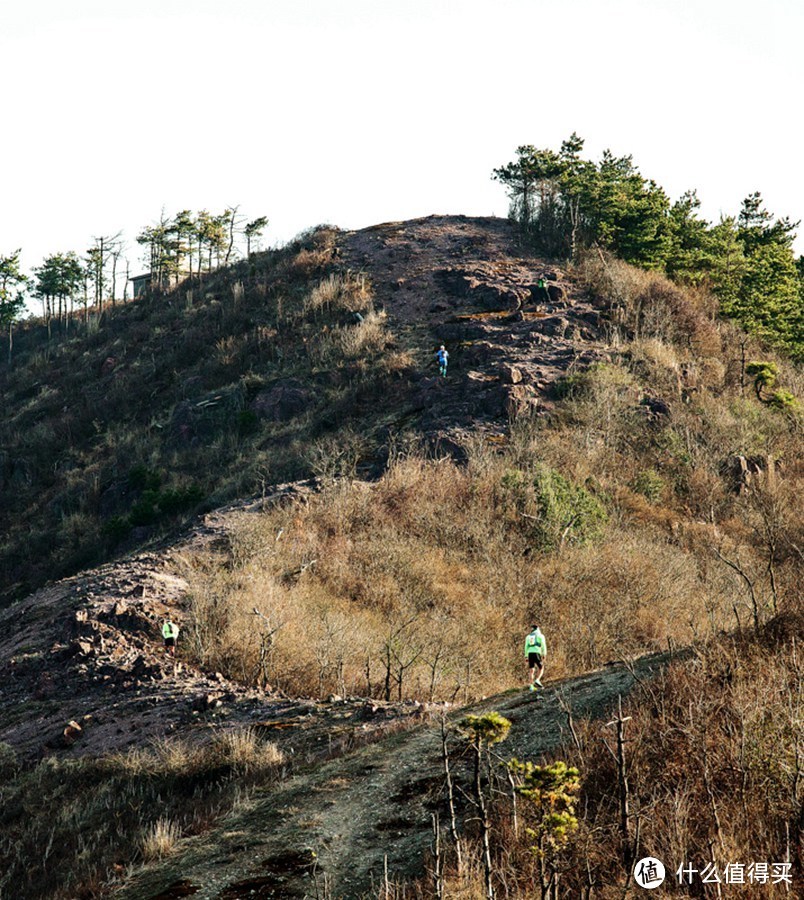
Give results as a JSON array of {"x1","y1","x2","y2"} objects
[{"x1": 0, "y1": 482, "x2": 430, "y2": 761}]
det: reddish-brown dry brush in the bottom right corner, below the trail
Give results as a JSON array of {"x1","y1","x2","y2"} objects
[{"x1": 388, "y1": 607, "x2": 804, "y2": 900}]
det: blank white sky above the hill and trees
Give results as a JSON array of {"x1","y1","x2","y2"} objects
[{"x1": 0, "y1": 0, "x2": 804, "y2": 288}]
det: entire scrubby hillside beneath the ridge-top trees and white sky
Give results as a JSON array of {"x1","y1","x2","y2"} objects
[{"x1": 0, "y1": 216, "x2": 804, "y2": 900}]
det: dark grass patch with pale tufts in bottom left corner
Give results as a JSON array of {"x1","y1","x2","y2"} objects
[{"x1": 0, "y1": 730, "x2": 284, "y2": 900}]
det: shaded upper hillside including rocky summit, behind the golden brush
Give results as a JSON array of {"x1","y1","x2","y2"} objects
[{"x1": 0, "y1": 217, "x2": 598, "y2": 602}]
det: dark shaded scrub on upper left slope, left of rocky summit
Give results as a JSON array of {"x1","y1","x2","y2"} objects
[{"x1": 0, "y1": 228, "x2": 410, "y2": 602}]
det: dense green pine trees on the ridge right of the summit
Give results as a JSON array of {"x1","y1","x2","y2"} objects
[{"x1": 492, "y1": 134, "x2": 804, "y2": 360}]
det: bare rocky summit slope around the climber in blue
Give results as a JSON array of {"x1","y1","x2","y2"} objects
[{"x1": 343, "y1": 216, "x2": 607, "y2": 445}]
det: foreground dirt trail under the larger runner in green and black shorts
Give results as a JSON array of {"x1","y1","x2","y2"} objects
[{"x1": 117, "y1": 654, "x2": 669, "y2": 900}]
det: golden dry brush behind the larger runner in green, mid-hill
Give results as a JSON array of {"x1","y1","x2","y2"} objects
[{"x1": 181, "y1": 443, "x2": 768, "y2": 700}]
